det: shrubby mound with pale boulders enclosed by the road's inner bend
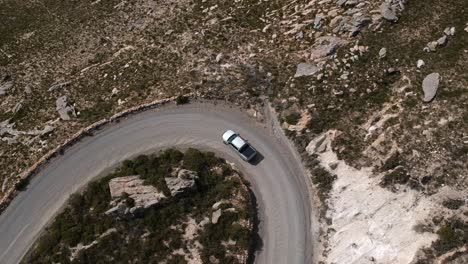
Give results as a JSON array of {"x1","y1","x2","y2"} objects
[{"x1": 23, "y1": 149, "x2": 254, "y2": 263}]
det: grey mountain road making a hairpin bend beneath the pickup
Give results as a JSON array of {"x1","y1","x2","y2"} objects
[{"x1": 0, "y1": 103, "x2": 312, "y2": 264}]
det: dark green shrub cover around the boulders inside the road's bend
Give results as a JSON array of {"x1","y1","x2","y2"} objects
[{"x1": 23, "y1": 149, "x2": 252, "y2": 263}]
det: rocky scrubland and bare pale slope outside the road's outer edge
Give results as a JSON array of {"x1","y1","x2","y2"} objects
[{"x1": 0, "y1": 0, "x2": 468, "y2": 263}]
